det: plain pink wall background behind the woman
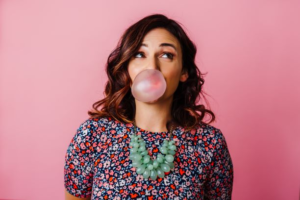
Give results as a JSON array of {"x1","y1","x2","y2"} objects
[{"x1": 0, "y1": 0, "x2": 300, "y2": 200}]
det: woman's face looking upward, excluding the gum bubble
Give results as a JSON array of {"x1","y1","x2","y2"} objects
[{"x1": 128, "y1": 28, "x2": 188, "y2": 102}]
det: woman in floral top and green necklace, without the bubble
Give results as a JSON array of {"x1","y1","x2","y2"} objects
[{"x1": 64, "y1": 14, "x2": 233, "y2": 200}]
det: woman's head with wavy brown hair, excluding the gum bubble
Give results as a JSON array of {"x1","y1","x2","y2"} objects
[{"x1": 88, "y1": 14, "x2": 215, "y2": 130}]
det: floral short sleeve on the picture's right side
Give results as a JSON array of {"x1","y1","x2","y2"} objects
[{"x1": 204, "y1": 129, "x2": 233, "y2": 200}]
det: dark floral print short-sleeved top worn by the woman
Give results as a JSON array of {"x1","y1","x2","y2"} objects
[{"x1": 64, "y1": 117, "x2": 233, "y2": 200}]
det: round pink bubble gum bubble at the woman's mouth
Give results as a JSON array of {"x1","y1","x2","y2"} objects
[{"x1": 131, "y1": 69, "x2": 167, "y2": 102}]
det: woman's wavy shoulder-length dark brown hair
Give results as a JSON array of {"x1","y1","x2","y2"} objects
[{"x1": 88, "y1": 14, "x2": 215, "y2": 131}]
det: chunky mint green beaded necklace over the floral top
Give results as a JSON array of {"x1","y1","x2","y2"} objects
[{"x1": 129, "y1": 121, "x2": 177, "y2": 180}]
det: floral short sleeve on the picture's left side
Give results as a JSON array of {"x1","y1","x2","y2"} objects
[{"x1": 64, "y1": 120, "x2": 94, "y2": 198}]
